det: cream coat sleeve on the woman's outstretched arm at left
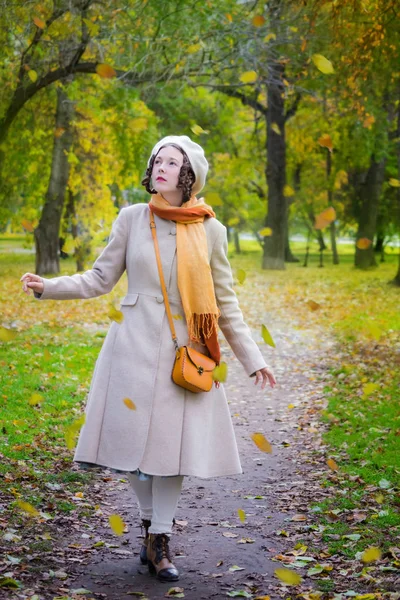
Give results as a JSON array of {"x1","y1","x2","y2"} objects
[{"x1": 35, "y1": 209, "x2": 128, "y2": 300}]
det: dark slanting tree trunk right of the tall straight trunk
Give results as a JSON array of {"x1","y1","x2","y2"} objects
[{"x1": 354, "y1": 156, "x2": 386, "y2": 269}]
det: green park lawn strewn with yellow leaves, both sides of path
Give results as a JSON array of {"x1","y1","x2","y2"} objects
[{"x1": 0, "y1": 242, "x2": 400, "y2": 555}]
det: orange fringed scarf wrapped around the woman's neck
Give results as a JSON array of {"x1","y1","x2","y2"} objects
[{"x1": 149, "y1": 194, "x2": 221, "y2": 364}]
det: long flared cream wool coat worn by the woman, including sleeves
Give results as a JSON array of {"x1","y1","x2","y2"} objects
[{"x1": 40, "y1": 204, "x2": 266, "y2": 478}]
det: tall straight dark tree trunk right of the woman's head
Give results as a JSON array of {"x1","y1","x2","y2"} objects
[{"x1": 262, "y1": 69, "x2": 287, "y2": 269}]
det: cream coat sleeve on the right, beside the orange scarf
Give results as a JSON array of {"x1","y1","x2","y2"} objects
[{"x1": 210, "y1": 227, "x2": 267, "y2": 376}]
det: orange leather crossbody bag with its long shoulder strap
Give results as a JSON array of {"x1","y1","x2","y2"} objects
[{"x1": 150, "y1": 210, "x2": 216, "y2": 393}]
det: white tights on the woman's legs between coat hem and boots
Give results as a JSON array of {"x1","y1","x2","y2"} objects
[{"x1": 128, "y1": 473, "x2": 183, "y2": 533}]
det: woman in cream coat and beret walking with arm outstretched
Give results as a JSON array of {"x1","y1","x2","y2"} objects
[{"x1": 21, "y1": 136, "x2": 275, "y2": 581}]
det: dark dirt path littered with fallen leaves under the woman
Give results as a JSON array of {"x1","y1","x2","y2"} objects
[{"x1": 47, "y1": 328, "x2": 334, "y2": 600}]
